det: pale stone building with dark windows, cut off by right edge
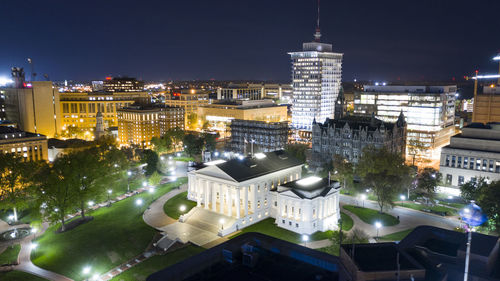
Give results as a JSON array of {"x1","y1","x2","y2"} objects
[{"x1": 439, "y1": 123, "x2": 500, "y2": 188}]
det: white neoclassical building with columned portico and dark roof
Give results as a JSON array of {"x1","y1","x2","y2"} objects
[{"x1": 186, "y1": 150, "x2": 340, "y2": 235}]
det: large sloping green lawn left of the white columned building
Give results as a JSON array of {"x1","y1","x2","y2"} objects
[{"x1": 31, "y1": 178, "x2": 186, "y2": 280}]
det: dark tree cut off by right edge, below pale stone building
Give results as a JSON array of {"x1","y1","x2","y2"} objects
[{"x1": 478, "y1": 181, "x2": 500, "y2": 229}]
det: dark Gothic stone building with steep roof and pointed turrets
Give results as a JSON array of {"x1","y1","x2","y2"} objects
[{"x1": 311, "y1": 113, "x2": 406, "y2": 168}]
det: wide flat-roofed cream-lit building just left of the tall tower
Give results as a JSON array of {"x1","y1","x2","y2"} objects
[{"x1": 198, "y1": 100, "x2": 287, "y2": 138}]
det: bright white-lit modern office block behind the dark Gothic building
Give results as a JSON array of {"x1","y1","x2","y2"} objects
[{"x1": 354, "y1": 85, "x2": 457, "y2": 165}]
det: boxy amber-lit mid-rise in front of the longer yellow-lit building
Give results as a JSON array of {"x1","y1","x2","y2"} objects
[{"x1": 117, "y1": 105, "x2": 184, "y2": 147}]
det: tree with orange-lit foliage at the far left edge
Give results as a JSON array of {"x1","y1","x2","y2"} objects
[{"x1": 0, "y1": 153, "x2": 37, "y2": 221}]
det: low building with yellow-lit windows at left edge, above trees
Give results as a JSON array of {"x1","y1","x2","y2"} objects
[{"x1": 0, "y1": 126, "x2": 48, "y2": 161}]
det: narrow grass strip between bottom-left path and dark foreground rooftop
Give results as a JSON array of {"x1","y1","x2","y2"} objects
[{"x1": 112, "y1": 245, "x2": 204, "y2": 281}]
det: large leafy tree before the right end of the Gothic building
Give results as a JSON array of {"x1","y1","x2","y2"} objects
[{"x1": 356, "y1": 147, "x2": 411, "y2": 212}]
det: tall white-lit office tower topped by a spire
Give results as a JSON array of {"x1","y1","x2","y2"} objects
[{"x1": 288, "y1": 9, "x2": 343, "y2": 131}]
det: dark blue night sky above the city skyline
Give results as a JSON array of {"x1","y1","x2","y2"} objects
[{"x1": 0, "y1": 0, "x2": 500, "y2": 81}]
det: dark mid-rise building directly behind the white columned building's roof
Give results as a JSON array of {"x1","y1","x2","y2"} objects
[{"x1": 229, "y1": 119, "x2": 289, "y2": 155}]
